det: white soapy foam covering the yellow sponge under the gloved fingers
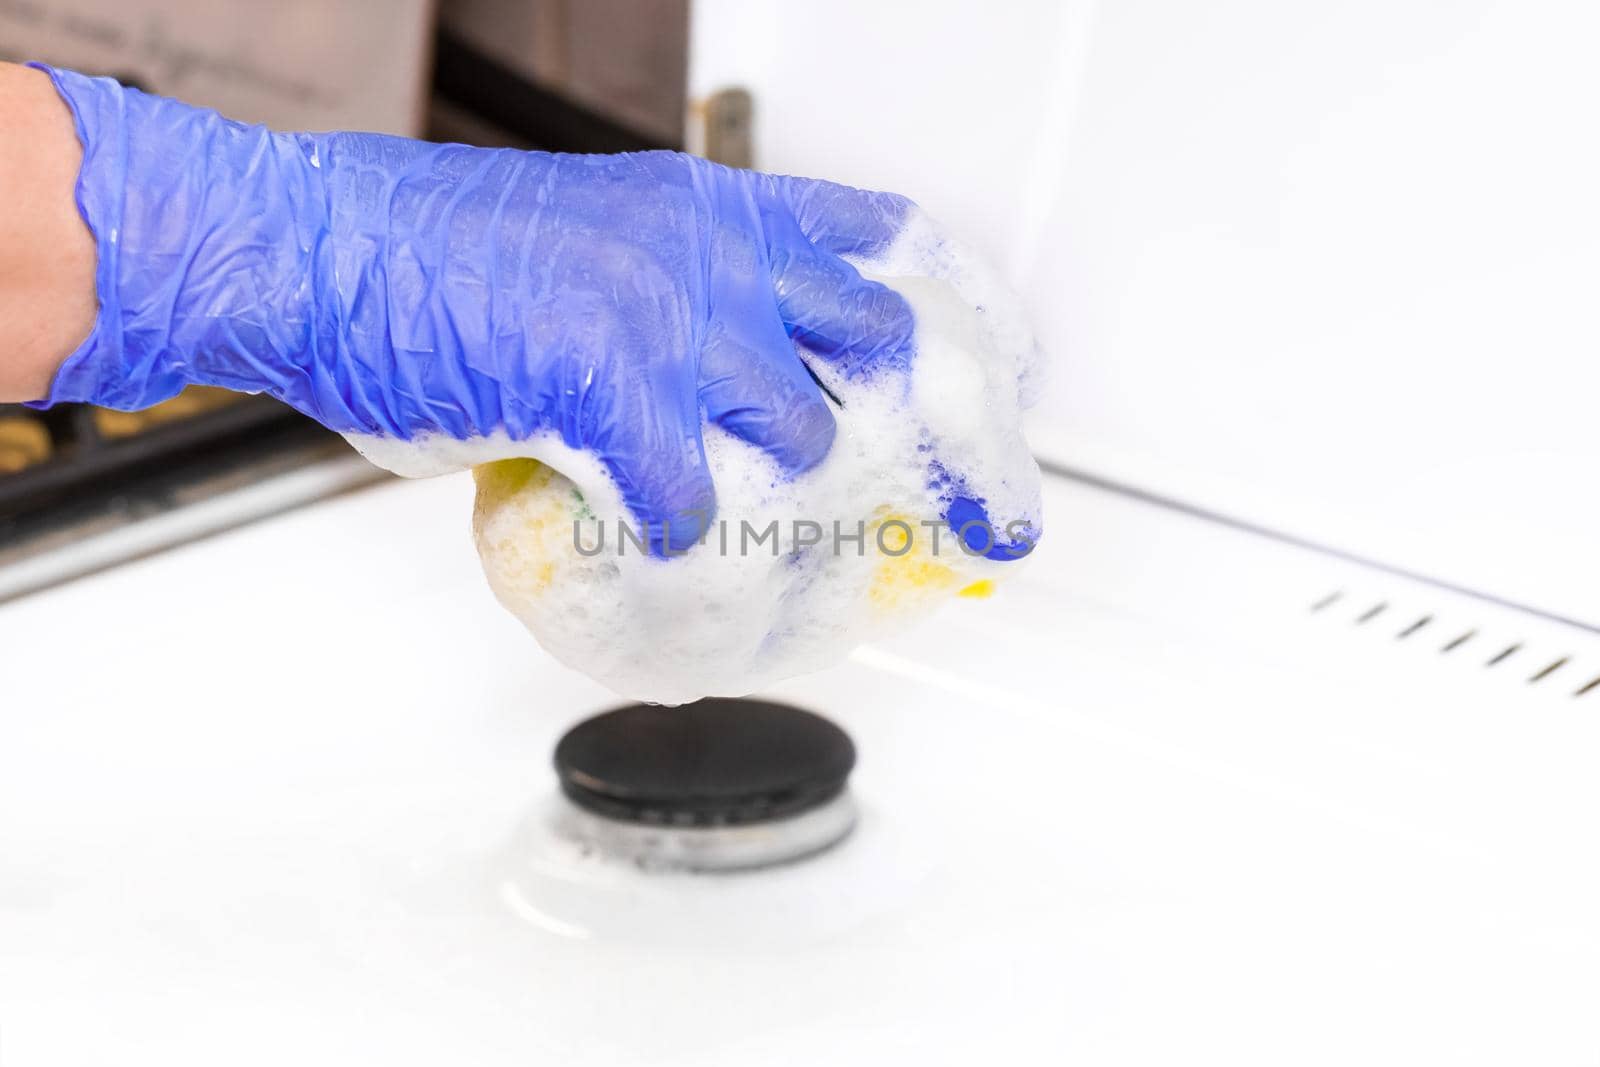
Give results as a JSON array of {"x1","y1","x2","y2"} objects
[{"x1": 352, "y1": 209, "x2": 1040, "y2": 704}]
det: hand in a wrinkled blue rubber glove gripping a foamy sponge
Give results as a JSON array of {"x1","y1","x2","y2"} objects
[{"x1": 34, "y1": 67, "x2": 1036, "y2": 552}]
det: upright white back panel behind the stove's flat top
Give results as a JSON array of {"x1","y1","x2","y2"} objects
[{"x1": 693, "y1": 0, "x2": 1600, "y2": 621}]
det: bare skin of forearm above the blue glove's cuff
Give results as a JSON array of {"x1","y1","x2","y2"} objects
[{"x1": 0, "y1": 62, "x2": 98, "y2": 403}]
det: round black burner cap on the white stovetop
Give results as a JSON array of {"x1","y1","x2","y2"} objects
[{"x1": 555, "y1": 697, "x2": 856, "y2": 827}]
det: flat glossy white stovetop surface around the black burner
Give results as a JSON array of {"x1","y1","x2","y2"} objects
[{"x1": 0, "y1": 477, "x2": 1600, "y2": 1067}]
